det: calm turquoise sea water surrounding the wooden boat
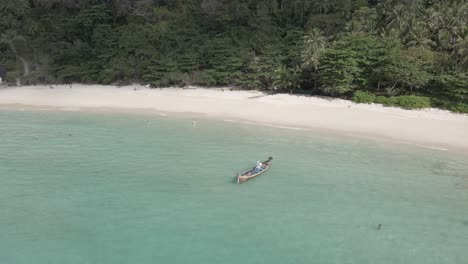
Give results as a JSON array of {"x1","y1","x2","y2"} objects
[{"x1": 0, "y1": 111, "x2": 468, "y2": 264}]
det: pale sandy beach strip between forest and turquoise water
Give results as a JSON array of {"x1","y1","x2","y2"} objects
[{"x1": 0, "y1": 84, "x2": 468, "y2": 150}]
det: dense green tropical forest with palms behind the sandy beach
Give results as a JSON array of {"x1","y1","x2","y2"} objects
[{"x1": 0, "y1": 0, "x2": 468, "y2": 111}]
